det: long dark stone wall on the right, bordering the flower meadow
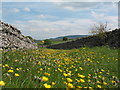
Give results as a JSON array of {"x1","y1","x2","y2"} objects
[{"x1": 47, "y1": 29, "x2": 120, "y2": 49}]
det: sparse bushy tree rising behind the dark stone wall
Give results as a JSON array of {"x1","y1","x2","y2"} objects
[{"x1": 90, "y1": 22, "x2": 109, "y2": 38}]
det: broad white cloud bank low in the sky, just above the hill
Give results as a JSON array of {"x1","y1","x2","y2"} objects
[{"x1": 12, "y1": 12, "x2": 118, "y2": 39}]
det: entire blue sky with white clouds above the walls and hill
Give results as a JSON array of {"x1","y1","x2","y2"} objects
[{"x1": 0, "y1": 0, "x2": 118, "y2": 39}]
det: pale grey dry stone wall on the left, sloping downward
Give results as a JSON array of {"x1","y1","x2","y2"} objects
[{"x1": 0, "y1": 21, "x2": 37, "y2": 49}]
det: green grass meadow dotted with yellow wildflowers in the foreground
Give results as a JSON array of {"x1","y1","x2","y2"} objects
[{"x1": 0, "y1": 47, "x2": 119, "y2": 89}]
